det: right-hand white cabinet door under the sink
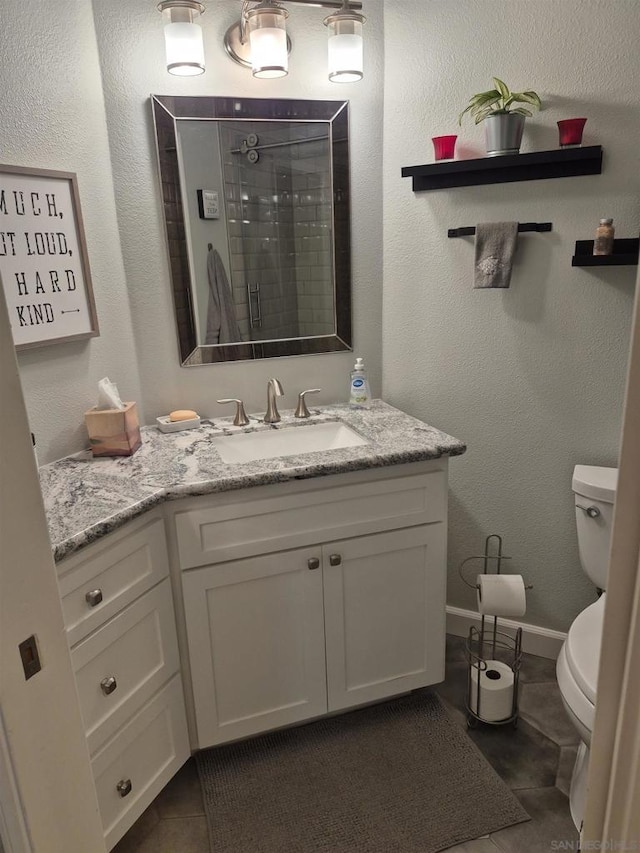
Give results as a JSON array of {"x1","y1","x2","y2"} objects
[{"x1": 323, "y1": 523, "x2": 446, "y2": 711}]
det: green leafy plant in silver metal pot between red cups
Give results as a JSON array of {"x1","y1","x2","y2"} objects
[{"x1": 458, "y1": 77, "x2": 542, "y2": 157}]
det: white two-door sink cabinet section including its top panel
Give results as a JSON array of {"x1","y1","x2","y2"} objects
[{"x1": 174, "y1": 458, "x2": 447, "y2": 748}]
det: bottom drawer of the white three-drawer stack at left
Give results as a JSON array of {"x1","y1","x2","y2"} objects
[{"x1": 91, "y1": 675, "x2": 189, "y2": 850}]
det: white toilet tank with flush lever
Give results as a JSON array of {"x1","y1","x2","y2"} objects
[{"x1": 571, "y1": 465, "x2": 618, "y2": 589}]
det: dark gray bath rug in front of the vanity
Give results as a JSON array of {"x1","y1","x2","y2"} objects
[{"x1": 195, "y1": 690, "x2": 529, "y2": 853}]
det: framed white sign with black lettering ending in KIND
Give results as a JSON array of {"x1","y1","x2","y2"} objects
[{"x1": 0, "y1": 165, "x2": 100, "y2": 350}]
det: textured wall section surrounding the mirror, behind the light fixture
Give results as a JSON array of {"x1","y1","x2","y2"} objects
[{"x1": 93, "y1": 0, "x2": 383, "y2": 421}]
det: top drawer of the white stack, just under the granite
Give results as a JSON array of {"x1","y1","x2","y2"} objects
[{"x1": 58, "y1": 518, "x2": 169, "y2": 646}]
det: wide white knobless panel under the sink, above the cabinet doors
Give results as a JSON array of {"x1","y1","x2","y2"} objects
[{"x1": 175, "y1": 460, "x2": 447, "y2": 569}]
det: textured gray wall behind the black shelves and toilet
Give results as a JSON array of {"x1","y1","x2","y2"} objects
[{"x1": 383, "y1": 0, "x2": 640, "y2": 629}]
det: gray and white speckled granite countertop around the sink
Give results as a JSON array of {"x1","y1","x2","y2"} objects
[{"x1": 40, "y1": 400, "x2": 466, "y2": 560}]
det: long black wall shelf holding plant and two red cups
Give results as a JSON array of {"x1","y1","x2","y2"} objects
[{"x1": 402, "y1": 145, "x2": 602, "y2": 192}]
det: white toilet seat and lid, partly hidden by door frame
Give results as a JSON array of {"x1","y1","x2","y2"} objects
[{"x1": 556, "y1": 595, "x2": 605, "y2": 745}]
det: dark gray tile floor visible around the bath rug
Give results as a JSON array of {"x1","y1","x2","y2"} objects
[{"x1": 113, "y1": 636, "x2": 578, "y2": 853}]
